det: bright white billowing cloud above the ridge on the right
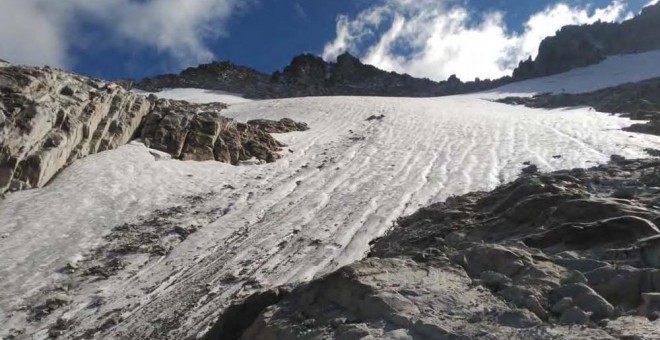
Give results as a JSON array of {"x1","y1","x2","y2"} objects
[{"x1": 323, "y1": 0, "x2": 630, "y2": 80}]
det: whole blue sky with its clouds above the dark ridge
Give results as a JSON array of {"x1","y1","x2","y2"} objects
[{"x1": 0, "y1": 0, "x2": 649, "y2": 80}]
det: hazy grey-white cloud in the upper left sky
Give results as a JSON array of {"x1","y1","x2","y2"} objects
[{"x1": 0, "y1": 0, "x2": 250, "y2": 67}]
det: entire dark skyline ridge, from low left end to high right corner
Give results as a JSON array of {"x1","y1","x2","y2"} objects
[{"x1": 134, "y1": 4, "x2": 660, "y2": 99}]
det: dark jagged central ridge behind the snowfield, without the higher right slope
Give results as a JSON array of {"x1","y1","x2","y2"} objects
[{"x1": 134, "y1": 53, "x2": 510, "y2": 99}]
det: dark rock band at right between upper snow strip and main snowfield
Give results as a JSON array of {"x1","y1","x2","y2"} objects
[{"x1": 498, "y1": 78, "x2": 660, "y2": 135}]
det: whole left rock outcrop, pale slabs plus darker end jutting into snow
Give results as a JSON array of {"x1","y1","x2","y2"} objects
[{"x1": 0, "y1": 66, "x2": 307, "y2": 193}]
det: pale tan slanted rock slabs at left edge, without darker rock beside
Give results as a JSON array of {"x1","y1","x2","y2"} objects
[{"x1": 0, "y1": 63, "x2": 152, "y2": 192}]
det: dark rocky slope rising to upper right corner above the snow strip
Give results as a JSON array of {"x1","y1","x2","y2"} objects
[{"x1": 513, "y1": 4, "x2": 660, "y2": 80}]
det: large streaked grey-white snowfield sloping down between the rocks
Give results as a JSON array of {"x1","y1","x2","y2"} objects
[{"x1": 0, "y1": 52, "x2": 660, "y2": 339}]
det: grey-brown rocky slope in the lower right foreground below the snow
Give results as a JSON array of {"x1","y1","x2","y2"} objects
[{"x1": 207, "y1": 157, "x2": 660, "y2": 339}]
